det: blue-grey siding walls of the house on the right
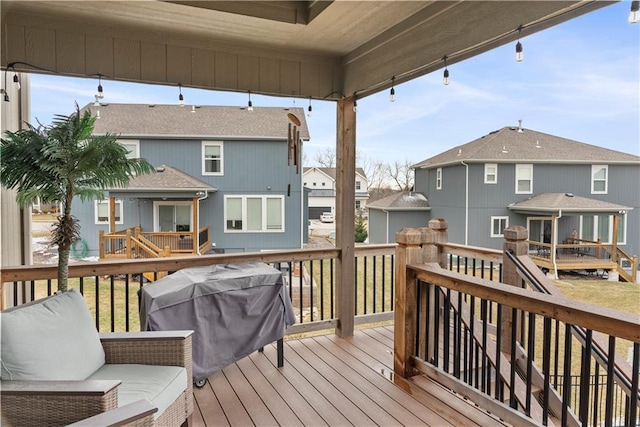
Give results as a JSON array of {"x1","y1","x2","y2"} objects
[{"x1": 415, "y1": 161, "x2": 640, "y2": 255}]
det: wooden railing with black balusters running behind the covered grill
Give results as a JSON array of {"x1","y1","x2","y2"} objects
[{"x1": 0, "y1": 245, "x2": 395, "y2": 334}]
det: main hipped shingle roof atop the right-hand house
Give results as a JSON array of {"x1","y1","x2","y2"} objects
[{"x1": 413, "y1": 127, "x2": 640, "y2": 168}]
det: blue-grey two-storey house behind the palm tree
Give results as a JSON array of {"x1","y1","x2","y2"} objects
[{"x1": 74, "y1": 104, "x2": 309, "y2": 255}]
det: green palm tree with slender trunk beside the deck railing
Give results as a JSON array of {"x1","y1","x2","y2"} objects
[{"x1": 0, "y1": 104, "x2": 153, "y2": 291}]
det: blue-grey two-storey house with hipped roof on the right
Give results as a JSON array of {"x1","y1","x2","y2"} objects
[{"x1": 370, "y1": 123, "x2": 640, "y2": 255}]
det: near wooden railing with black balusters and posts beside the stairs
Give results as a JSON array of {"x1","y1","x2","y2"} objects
[{"x1": 394, "y1": 221, "x2": 640, "y2": 426}]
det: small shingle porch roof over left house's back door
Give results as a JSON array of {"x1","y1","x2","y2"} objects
[{"x1": 113, "y1": 165, "x2": 217, "y2": 192}]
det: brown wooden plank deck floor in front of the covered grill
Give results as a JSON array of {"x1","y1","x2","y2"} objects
[{"x1": 193, "y1": 326, "x2": 504, "y2": 426}]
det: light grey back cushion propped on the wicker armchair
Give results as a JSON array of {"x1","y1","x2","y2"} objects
[{"x1": 0, "y1": 289, "x2": 105, "y2": 381}]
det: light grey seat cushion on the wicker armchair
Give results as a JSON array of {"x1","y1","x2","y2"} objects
[{"x1": 88, "y1": 364, "x2": 187, "y2": 418}]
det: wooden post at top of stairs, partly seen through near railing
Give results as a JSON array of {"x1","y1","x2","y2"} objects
[{"x1": 500, "y1": 225, "x2": 528, "y2": 355}]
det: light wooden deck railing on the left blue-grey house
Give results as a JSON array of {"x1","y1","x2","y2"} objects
[{"x1": 99, "y1": 226, "x2": 211, "y2": 260}]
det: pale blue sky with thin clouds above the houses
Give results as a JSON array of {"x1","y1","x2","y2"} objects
[{"x1": 30, "y1": 1, "x2": 640, "y2": 166}]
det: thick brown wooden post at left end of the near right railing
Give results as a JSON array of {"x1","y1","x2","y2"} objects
[{"x1": 393, "y1": 228, "x2": 423, "y2": 378}]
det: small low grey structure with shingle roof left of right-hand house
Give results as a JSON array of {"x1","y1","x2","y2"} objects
[{"x1": 367, "y1": 191, "x2": 431, "y2": 243}]
